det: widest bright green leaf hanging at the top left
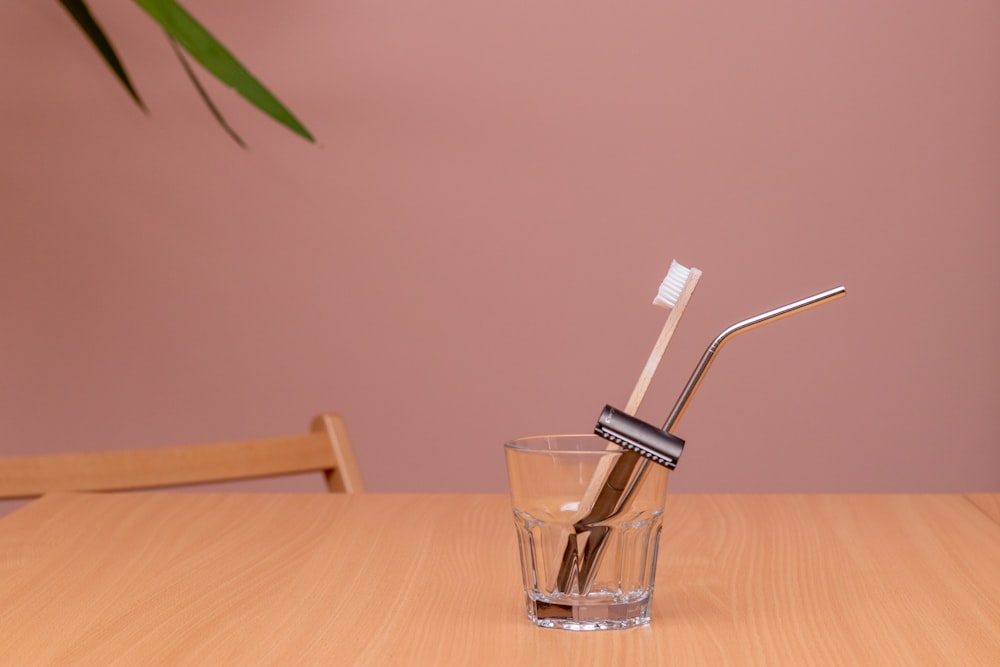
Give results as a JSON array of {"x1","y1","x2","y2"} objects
[{"x1": 135, "y1": 0, "x2": 314, "y2": 141}]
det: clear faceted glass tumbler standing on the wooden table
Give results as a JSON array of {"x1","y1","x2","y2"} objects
[{"x1": 504, "y1": 435, "x2": 670, "y2": 630}]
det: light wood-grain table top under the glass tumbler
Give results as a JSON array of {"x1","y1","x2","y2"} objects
[{"x1": 0, "y1": 494, "x2": 1000, "y2": 667}]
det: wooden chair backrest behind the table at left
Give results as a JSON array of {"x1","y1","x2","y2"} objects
[{"x1": 0, "y1": 414, "x2": 364, "y2": 499}]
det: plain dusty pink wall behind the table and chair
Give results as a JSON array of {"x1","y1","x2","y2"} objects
[{"x1": 0, "y1": 0, "x2": 1000, "y2": 509}]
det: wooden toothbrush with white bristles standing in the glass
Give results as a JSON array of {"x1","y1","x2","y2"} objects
[{"x1": 556, "y1": 260, "x2": 701, "y2": 591}]
